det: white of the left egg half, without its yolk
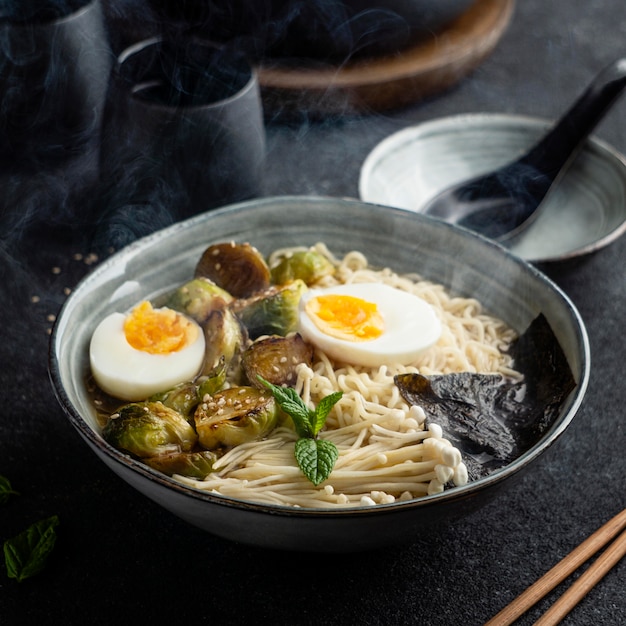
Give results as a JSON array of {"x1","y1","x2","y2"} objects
[{"x1": 89, "y1": 313, "x2": 205, "y2": 401}]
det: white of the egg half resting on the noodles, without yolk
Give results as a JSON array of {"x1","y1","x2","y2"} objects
[{"x1": 299, "y1": 283, "x2": 441, "y2": 367}]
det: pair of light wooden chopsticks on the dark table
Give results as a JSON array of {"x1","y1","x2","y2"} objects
[{"x1": 485, "y1": 509, "x2": 626, "y2": 626}]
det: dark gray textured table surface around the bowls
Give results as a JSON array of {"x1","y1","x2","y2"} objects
[{"x1": 0, "y1": 0, "x2": 626, "y2": 626}]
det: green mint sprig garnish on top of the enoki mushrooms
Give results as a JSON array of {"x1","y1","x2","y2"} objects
[{"x1": 257, "y1": 376, "x2": 343, "y2": 487}]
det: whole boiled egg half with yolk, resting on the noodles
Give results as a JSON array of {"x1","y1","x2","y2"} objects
[{"x1": 299, "y1": 283, "x2": 441, "y2": 367}]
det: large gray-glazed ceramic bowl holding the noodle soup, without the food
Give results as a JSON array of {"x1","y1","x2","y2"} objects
[{"x1": 49, "y1": 197, "x2": 589, "y2": 552}]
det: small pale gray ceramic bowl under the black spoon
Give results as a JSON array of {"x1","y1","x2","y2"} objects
[{"x1": 359, "y1": 114, "x2": 626, "y2": 262}]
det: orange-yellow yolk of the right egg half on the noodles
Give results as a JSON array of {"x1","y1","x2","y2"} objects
[{"x1": 305, "y1": 294, "x2": 385, "y2": 341}]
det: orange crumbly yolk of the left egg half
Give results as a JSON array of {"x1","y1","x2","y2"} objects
[{"x1": 124, "y1": 302, "x2": 198, "y2": 354}]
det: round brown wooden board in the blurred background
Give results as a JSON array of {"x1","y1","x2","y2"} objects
[{"x1": 258, "y1": 0, "x2": 515, "y2": 117}]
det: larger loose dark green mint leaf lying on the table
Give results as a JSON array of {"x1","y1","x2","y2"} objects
[{"x1": 4, "y1": 515, "x2": 59, "y2": 582}]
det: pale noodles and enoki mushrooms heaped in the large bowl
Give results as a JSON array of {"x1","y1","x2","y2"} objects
[{"x1": 123, "y1": 244, "x2": 518, "y2": 508}]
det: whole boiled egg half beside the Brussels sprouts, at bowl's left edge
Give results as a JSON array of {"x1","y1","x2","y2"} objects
[{"x1": 89, "y1": 302, "x2": 205, "y2": 401}]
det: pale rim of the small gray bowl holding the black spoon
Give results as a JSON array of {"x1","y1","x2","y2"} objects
[{"x1": 358, "y1": 112, "x2": 626, "y2": 264}]
